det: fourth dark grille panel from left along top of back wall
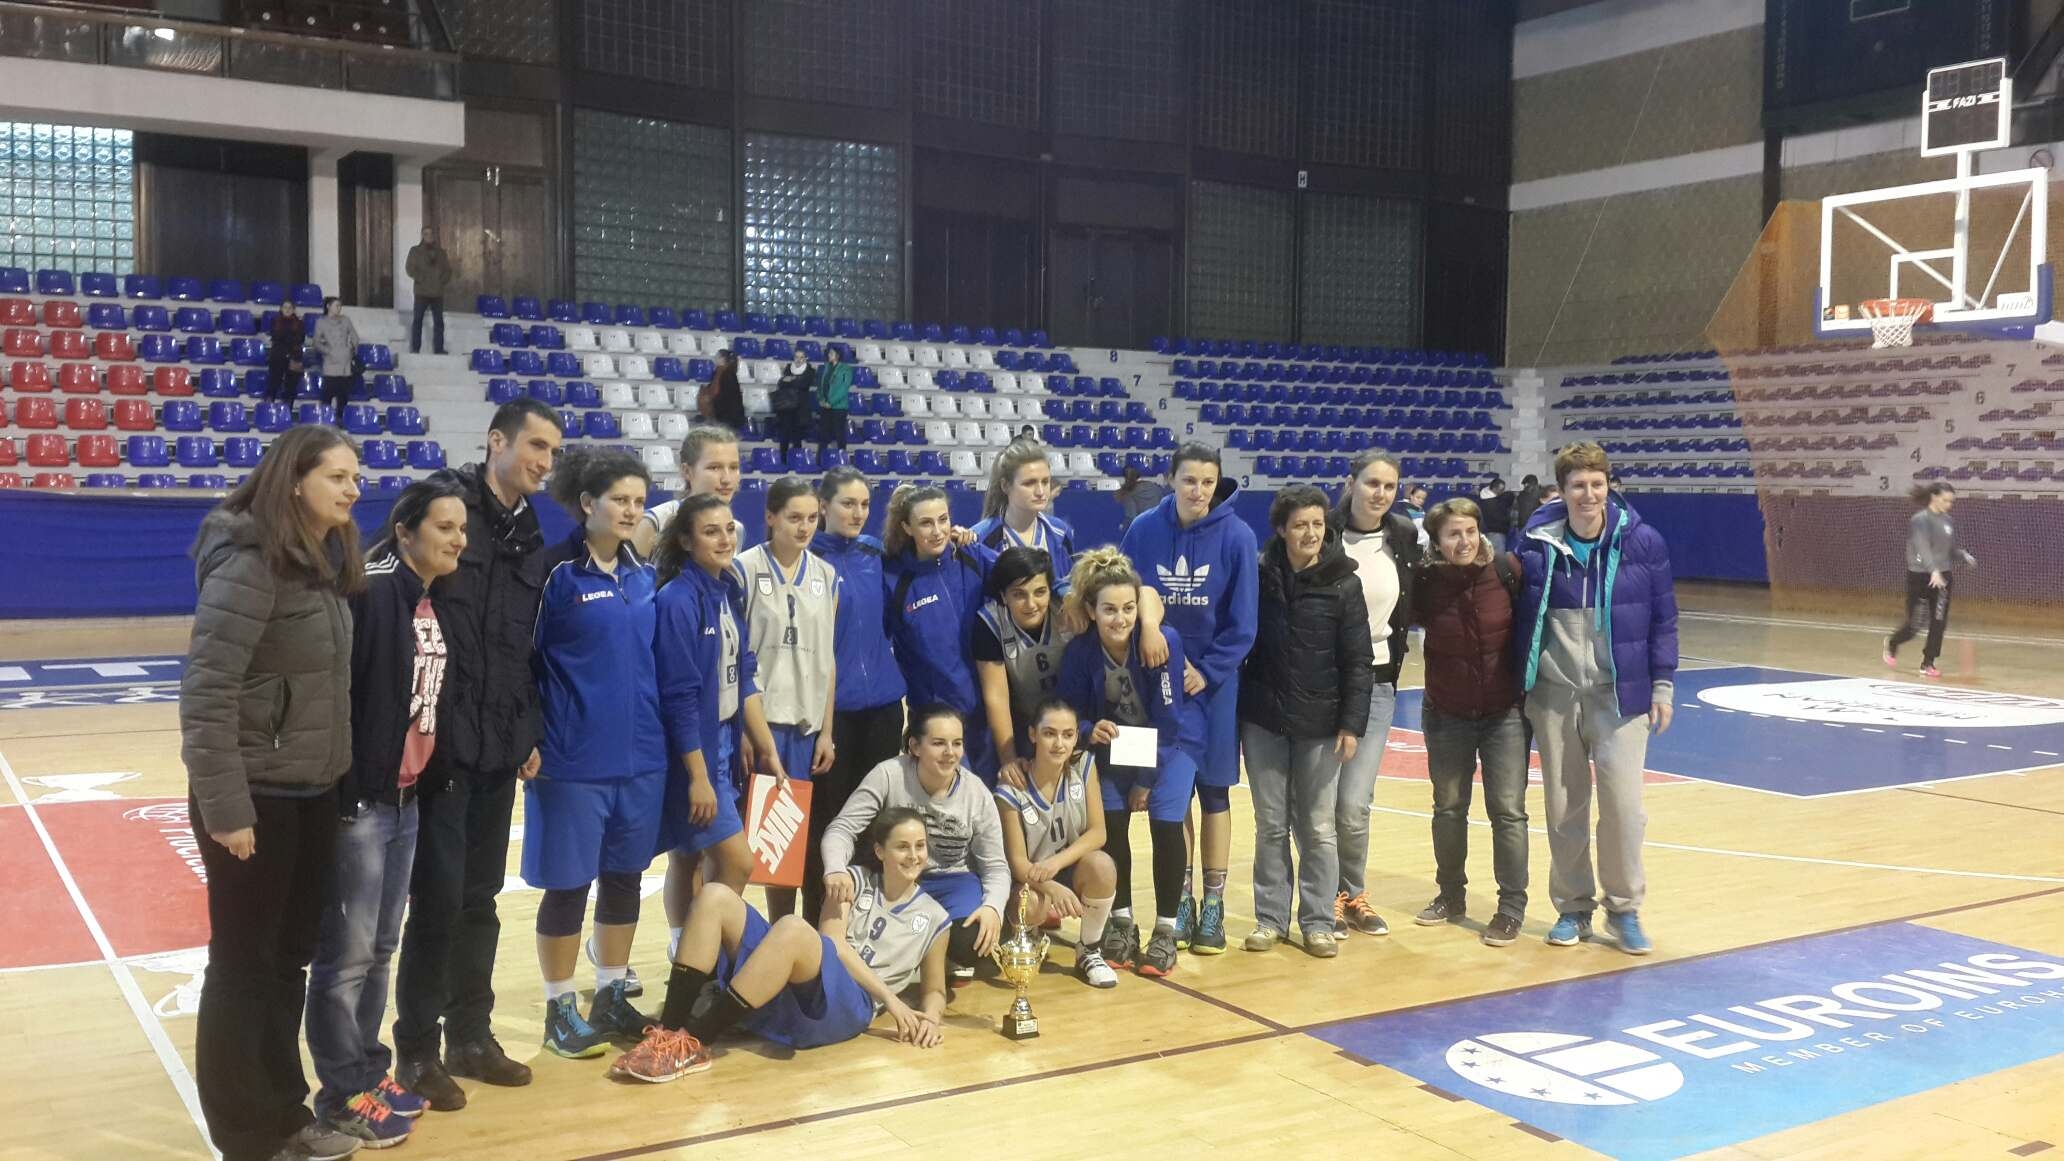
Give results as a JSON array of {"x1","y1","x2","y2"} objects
[{"x1": 1053, "y1": 0, "x2": 1185, "y2": 140}]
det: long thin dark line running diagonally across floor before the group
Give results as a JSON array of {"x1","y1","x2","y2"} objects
[{"x1": 574, "y1": 886, "x2": 2064, "y2": 1161}]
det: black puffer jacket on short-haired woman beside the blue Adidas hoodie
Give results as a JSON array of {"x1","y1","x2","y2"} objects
[{"x1": 1240, "y1": 529, "x2": 1377, "y2": 740}]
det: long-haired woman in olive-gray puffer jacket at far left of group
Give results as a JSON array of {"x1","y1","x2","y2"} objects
[{"x1": 180, "y1": 426, "x2": 365, "y2": 1161}]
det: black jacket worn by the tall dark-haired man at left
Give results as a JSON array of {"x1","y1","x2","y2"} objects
[{"x1": 436, "y1": 463, "x2": 545, "y2": 783}]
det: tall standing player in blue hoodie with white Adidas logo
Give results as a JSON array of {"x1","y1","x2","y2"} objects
[{"x1": 1123, "y1": 444, "x2": 1257, "y2": 954}]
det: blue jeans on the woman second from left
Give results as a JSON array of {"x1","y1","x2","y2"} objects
[{"x1": 308, "y1": 802, "x2": 417, "y2": 1116}]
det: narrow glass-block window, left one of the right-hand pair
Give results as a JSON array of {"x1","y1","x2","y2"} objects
[{"x1": 1187, "y1": 182, "x2": 1296, "y2": 339}]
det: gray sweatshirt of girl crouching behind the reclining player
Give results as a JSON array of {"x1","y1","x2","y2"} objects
[{"x1": 824, "y1": 754, "x2": 1011, "y2": 915}]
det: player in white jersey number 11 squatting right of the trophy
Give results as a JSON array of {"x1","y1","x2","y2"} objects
[{"x1": 997, "y1": 696, "x2": 1119, "y2": 987}]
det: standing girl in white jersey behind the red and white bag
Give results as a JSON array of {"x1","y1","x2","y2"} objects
[{"x1": 731, "y1": 475, "x2": 838, "y2": 919}]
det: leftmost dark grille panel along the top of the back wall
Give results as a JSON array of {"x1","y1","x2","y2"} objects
[{"x1": 578, "y1": 0, "x2": 731, "y2": 89}]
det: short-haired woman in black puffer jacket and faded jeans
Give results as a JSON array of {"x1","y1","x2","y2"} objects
[{"x1": 1240, "y1": 483, "x2": 1375, "y2": 959}]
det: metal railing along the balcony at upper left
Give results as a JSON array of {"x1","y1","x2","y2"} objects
[{"x1": 0, "y1": 0, "x2": 458, "y2": 101}]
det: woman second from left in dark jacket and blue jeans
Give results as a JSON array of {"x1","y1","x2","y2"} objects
[{"x1": 308, "y1": 479, "x2": 466, "y2": 1149}]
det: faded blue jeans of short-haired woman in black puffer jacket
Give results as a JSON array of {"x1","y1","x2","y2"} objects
[{"x1": 1240, "y1": 721, "x2": 1340, "y2": 936}]
